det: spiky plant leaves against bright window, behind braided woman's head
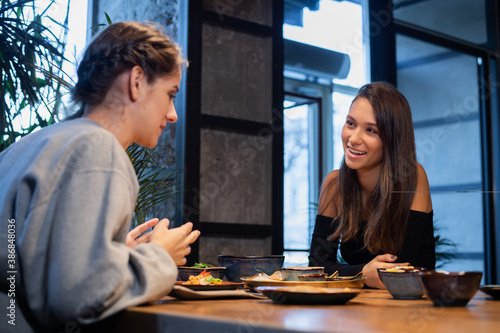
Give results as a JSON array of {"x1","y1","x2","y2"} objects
[{"x1": 0, "y1": 0, "x2": 71, "y2": 151}]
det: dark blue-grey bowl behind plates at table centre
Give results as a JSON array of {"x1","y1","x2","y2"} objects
[{"x1": 219, "y1": 255, "x2": 285, "y2": 282}]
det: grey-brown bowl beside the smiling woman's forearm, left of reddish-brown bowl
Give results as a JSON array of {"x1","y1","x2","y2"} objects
[{"x1": 377, "y1": 267, "x2": 425, "y2": 299}]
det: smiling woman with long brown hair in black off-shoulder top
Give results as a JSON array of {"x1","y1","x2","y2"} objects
[{"x1": 309, "y1": 83, "x2": 435, "y2": 288}]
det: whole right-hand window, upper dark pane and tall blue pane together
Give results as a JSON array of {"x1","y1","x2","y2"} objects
[{"x1": 394, "y1": 0, "x2": 488, "y2": 271}]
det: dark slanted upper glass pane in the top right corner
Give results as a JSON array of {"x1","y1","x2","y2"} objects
[{"x1": 393, "y1": 0, "x2": 488, "y2": 44}]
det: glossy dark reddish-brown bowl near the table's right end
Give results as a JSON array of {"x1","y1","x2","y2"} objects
[{"x1": 418, "y1": 271, "x2": 483, "y2": 306}]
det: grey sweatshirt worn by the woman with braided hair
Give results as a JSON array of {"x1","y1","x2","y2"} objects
[{"x1": 0, "y1": 118, "x2": 177, "y2": 332}]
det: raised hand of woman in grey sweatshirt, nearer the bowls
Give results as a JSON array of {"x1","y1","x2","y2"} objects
[{"x1": 151, "y1": 219, "x2": 200, "y2": 266}]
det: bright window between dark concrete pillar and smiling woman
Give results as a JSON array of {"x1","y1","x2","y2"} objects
[{"x1": 283, "y1": 0, "x2": 367, "y2": 266}]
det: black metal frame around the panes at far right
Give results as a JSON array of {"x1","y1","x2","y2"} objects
[{"x1": 369, "y1": 0, "x2": 500, "y2": 284}]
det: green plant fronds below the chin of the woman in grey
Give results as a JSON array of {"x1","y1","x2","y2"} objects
[{"x1": 127, "y1": 143, "x2": 179, "y2": 227}]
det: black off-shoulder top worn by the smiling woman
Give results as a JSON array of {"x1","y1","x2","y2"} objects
[{"x1": 309, "y1": 210, "x2": 436, "y2": 276}]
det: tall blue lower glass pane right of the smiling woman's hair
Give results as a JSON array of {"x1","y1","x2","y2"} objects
[{"x1": 396, "y1": 36, "x2": 484, "y2": 271}]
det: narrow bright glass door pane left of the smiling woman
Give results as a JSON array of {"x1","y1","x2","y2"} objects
[{"x1": 283, "y1": 101, "x2": 318, "y2": 250}]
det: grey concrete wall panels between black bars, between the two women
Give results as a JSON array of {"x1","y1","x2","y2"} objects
[{"x1": 199, "y1": 0, "x2": 273, "y2": 264}]
